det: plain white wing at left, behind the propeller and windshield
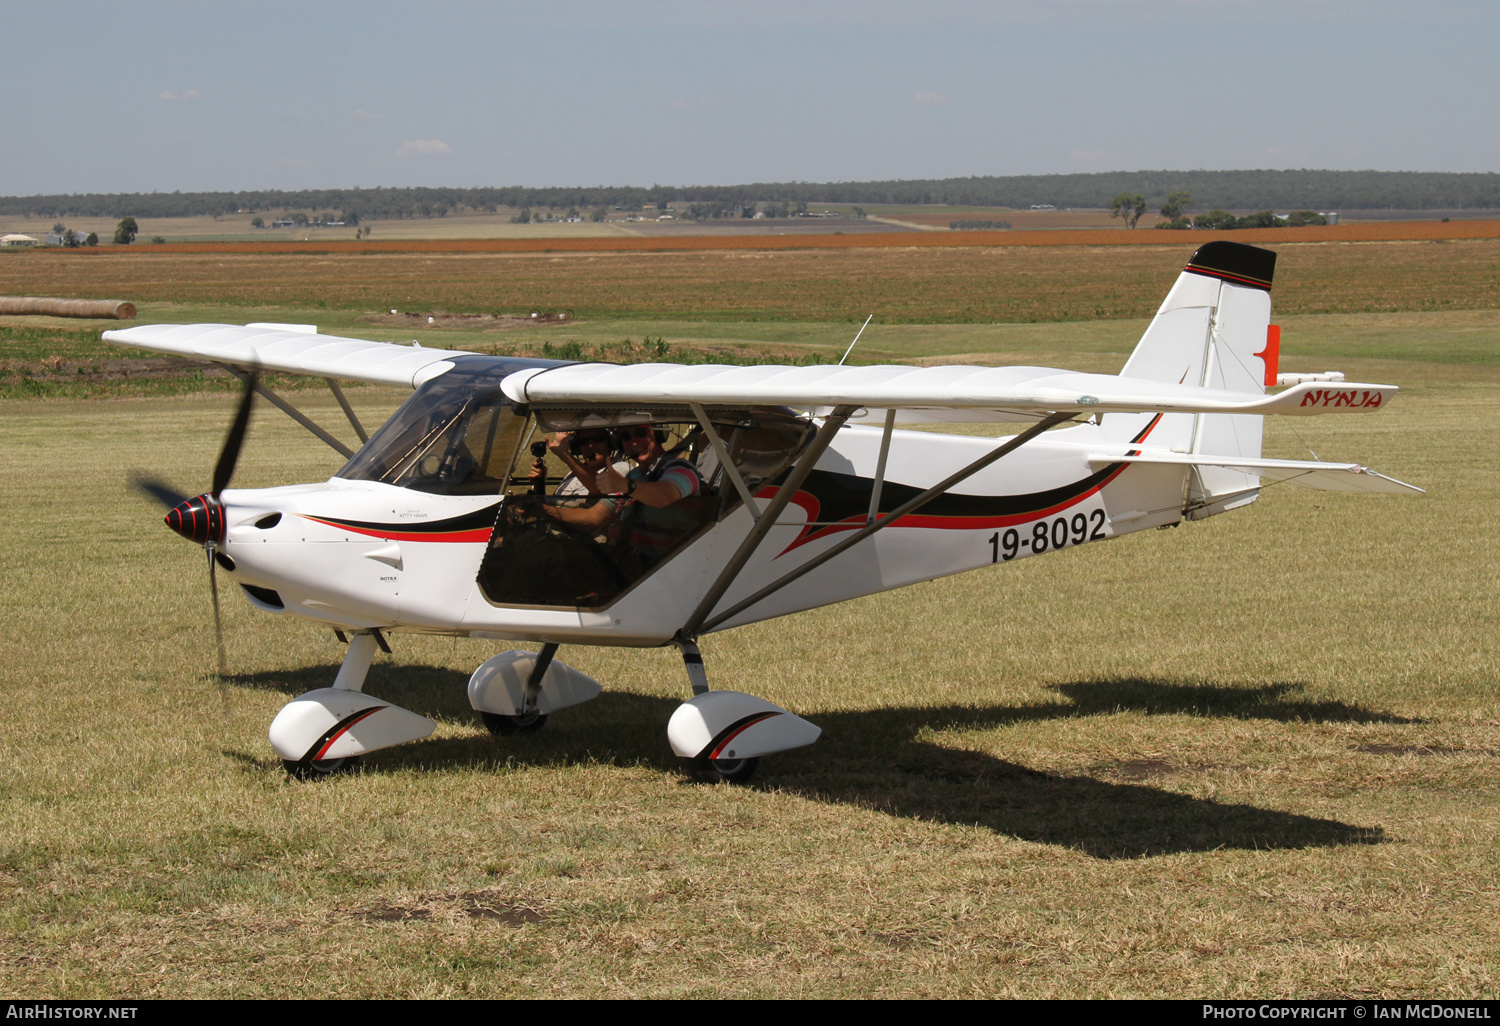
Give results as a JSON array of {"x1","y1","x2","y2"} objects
[{"x1": 102, "y1": 324, "x2": 471, "y2": 389}]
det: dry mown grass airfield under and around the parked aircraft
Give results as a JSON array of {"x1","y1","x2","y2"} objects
[{"x1": 0, "y1": 243, "x2": 1500, "y2": 999}]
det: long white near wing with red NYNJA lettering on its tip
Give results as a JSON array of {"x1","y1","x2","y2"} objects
[{"x1": 501, "y1": 363, "x2": 1397, "y2": 416}]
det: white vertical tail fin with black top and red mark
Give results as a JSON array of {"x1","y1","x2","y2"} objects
[{"x1": 1103, "y1": 242, "x2": 1277, "y2": 521}]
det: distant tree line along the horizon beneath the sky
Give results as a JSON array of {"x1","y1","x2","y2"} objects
[{"x1": 0, "y1": 171, "x2": 1500, "y2": 221}]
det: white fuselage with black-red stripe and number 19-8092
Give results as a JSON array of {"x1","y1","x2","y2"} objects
[{"x1": 221, "y1": 419, "x2": 1185, "y2": 645}]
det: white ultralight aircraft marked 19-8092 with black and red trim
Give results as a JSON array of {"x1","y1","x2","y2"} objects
[{"x1": 104, "y1": 242, "x2": 1422, "y2": 780}]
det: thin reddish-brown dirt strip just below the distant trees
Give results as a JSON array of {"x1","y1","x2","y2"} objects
[{"x1": 5, "y1": 219, "x2": 1500, "y2": 258}]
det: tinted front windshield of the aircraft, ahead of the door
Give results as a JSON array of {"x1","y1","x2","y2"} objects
[{"x1": 338, "y1": 356, "x2": 552, "y2": 495}]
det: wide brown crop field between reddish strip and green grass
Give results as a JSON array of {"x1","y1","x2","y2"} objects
[{"x1": 0, "y1": 237, "x2": 1500, "y2": 324}]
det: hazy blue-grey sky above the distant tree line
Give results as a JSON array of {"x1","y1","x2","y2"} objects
[{"x1": 0, "y1": 0, "x2": 1500, "y2": 195}]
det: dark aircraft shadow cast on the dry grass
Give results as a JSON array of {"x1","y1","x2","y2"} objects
[{"x1": 225, "y1": 666, "x2": 1392, "y2": 858}]
